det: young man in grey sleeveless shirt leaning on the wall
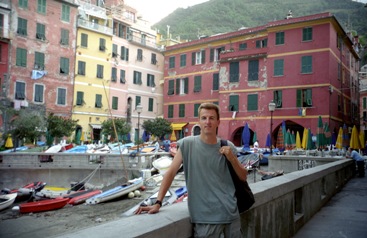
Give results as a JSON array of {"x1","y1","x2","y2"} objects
[{"x1": 135, "y1": 103, "x2": 247, "y2": 237}]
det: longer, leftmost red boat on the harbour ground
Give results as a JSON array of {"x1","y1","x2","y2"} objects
[{"x1": 19, "y1": 197, "x2": 69, "y2": 213}]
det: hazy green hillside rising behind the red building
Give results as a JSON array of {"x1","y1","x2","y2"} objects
[{"x1": 153, "y1": 0, "x2": 367, "y2": 44}]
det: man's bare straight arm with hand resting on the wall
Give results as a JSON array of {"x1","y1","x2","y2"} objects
[{"x1": 135, "y1": 149, "x2": 182, "y2": 214}]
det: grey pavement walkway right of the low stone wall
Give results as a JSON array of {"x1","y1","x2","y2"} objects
[{"x1": 294, "y1": 173, "x2": 367, "y2": 238}]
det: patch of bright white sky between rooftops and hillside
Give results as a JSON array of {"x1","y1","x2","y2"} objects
[{"x1": 125, "y1": 0, "x2": 210, "y2": 24}]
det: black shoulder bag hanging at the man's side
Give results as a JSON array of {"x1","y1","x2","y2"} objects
[{"x1": 220, "y1": 140, "x2": 255, "y2": 213}]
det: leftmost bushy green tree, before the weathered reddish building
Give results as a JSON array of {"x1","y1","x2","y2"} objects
[{"x1": 10, "y1": 110, "x2": 45, "y2": 144}]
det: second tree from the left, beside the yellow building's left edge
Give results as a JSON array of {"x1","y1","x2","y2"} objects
[{"x1": 47, "y1": 113, "x2": 78, "y2": 144}]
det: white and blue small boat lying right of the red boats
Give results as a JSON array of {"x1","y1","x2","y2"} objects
[{"x1": 86, "y1": 177, "x2": 143, "y2": 204}]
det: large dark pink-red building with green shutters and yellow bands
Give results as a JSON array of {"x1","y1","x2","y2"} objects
[{"x1": 164, "y1": 13, "x2": 359, "y2": 147}]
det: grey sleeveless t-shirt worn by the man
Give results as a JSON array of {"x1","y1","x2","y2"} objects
[{"x1": 178, "y1": 136, "x2": 238, "y2": 224}]
